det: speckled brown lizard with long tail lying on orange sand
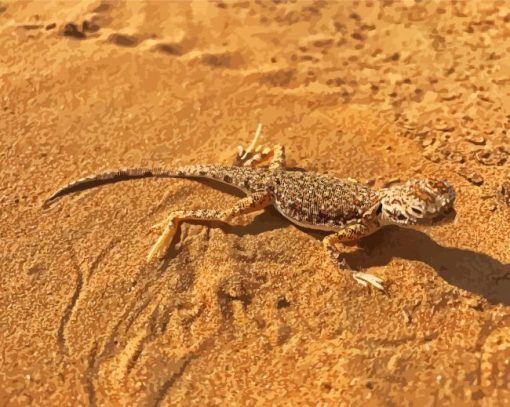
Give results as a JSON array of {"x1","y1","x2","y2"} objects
[{"x1": 44, "y1": 124, "x2": 455, "y2": 290}]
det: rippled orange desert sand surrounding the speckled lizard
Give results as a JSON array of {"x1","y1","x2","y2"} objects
[{"x1": 0, "y1": 0, "x2": 510, "y2": 406}]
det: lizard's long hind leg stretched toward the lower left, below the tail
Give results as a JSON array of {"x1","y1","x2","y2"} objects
[{"x1": 147, "y1": 192, "x2": 271, "y2": 262}]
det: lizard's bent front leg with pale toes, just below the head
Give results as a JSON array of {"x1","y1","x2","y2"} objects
[{"x1": 322, "y1": 222, "x2": 384, "y2": 291}]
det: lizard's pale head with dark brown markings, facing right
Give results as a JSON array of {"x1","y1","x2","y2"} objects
[{"x1": 376, "y1": 179, "x2": 455, "y2": 226}]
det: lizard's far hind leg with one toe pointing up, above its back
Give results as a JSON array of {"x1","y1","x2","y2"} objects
[{"x1": 234, "y1": 123, "x2": 285, "y2": 170}]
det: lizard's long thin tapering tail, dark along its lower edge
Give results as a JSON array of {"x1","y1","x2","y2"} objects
[{"x1": 43, "y1": 165, "x2": 237, "y2": 208}]
